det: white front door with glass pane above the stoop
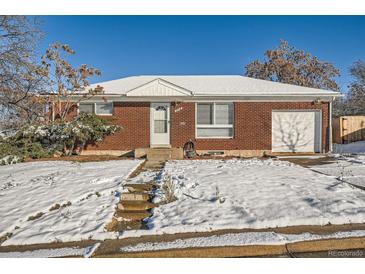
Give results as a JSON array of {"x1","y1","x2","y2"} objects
[{"x1": 151, "y1": 103, "x2": 170, "y2": 146}]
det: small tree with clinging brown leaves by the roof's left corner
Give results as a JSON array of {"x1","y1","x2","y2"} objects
[{"x1": 42, "y1": 43, "x2": 103, "y2": 121}]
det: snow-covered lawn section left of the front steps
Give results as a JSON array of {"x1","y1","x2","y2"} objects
[{"x1": 0, "y1": 160, "x2": 141, "y2": 245}]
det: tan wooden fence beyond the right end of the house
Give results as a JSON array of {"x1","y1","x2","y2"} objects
[{"x1": 332, "y1": 116, "x2": 365, "y2": 144}]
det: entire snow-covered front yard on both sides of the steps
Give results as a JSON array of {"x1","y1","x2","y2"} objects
[{"x1": 0, "y1": 157, "x2": 365, "y2": 245}]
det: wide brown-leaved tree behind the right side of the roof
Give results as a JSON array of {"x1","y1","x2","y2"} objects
[{"x1": 245, "y1": 40, "x2": 340, "y2": 91}]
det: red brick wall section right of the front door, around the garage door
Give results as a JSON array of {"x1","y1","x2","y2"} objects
[{"x1": 171, "y1": 102, "x2": 329, "y2": 151}]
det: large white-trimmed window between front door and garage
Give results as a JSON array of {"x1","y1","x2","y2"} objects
[{"x1": 196, "y1": 103, "x2": 233, "y2": 138}]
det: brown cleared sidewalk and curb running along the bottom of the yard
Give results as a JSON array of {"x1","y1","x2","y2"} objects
[{"x1": 0, "y1": 224, "x2": 365, "y2": 258}]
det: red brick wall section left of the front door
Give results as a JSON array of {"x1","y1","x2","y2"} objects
[{"x1": 86, "y1": 102, "x2": 150, "y2": 150}]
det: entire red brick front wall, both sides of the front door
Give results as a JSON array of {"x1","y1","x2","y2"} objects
[{"x1": 80, "y1": 102, "x2": 329, "y2": 151}]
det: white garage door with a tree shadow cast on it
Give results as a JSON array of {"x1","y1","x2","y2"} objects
[{"x1": 271, "y1": 111, "x2": 321, "y2": 152}]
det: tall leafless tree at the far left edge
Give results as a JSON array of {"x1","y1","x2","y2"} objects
[{"x1": 0, "y1": 15, "x2": 46, "y2": 127}]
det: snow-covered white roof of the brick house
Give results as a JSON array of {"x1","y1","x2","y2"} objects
[{"x1": 87, "y1": 75, "x2": 339, "y2": 96}]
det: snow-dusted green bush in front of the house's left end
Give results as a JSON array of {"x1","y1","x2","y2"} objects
[{"x1": 0, "y1": 113, "x2": 119, "y2": 161}]
